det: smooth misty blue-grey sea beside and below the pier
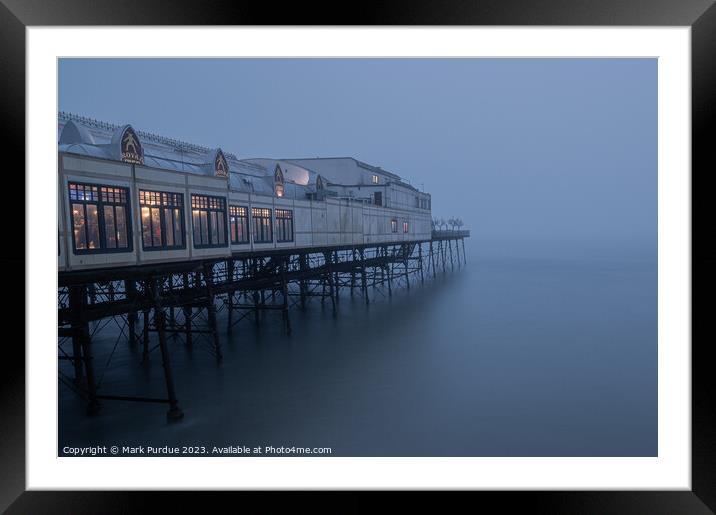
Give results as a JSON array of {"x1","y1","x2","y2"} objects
[{"x1": 59, "y1": 241, "x2": 657, "y2": 456}]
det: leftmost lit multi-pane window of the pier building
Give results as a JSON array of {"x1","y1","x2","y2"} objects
[{"x1": 68, "y1": 183, "x2": 132, "y2": 254}]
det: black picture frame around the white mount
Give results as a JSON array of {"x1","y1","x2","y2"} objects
[{"x1": 0, "y1": 0, "x2": 716, "y2": 514}]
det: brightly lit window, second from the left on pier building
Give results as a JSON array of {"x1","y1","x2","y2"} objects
[{"x1": 139, "y1": 190, "x2": 185, "y2": 250}]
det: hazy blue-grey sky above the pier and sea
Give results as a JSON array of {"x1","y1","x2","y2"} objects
[{"x1": 59, "y1": 59, "x2": 657, "y2": 243}]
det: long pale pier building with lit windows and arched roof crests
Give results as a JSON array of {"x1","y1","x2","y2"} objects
[{"x1": 57, "y1": 113, "x2": 431, "y2": 271}]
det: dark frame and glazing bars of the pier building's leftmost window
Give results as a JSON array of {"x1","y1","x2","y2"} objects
[{"x1": 66, "y1": 180, "x2": 134, "y2": 256}]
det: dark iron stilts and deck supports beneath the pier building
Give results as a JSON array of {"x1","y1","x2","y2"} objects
[{"x1": 58, "y1": 230, "x2": 470, "y2": 420}]
